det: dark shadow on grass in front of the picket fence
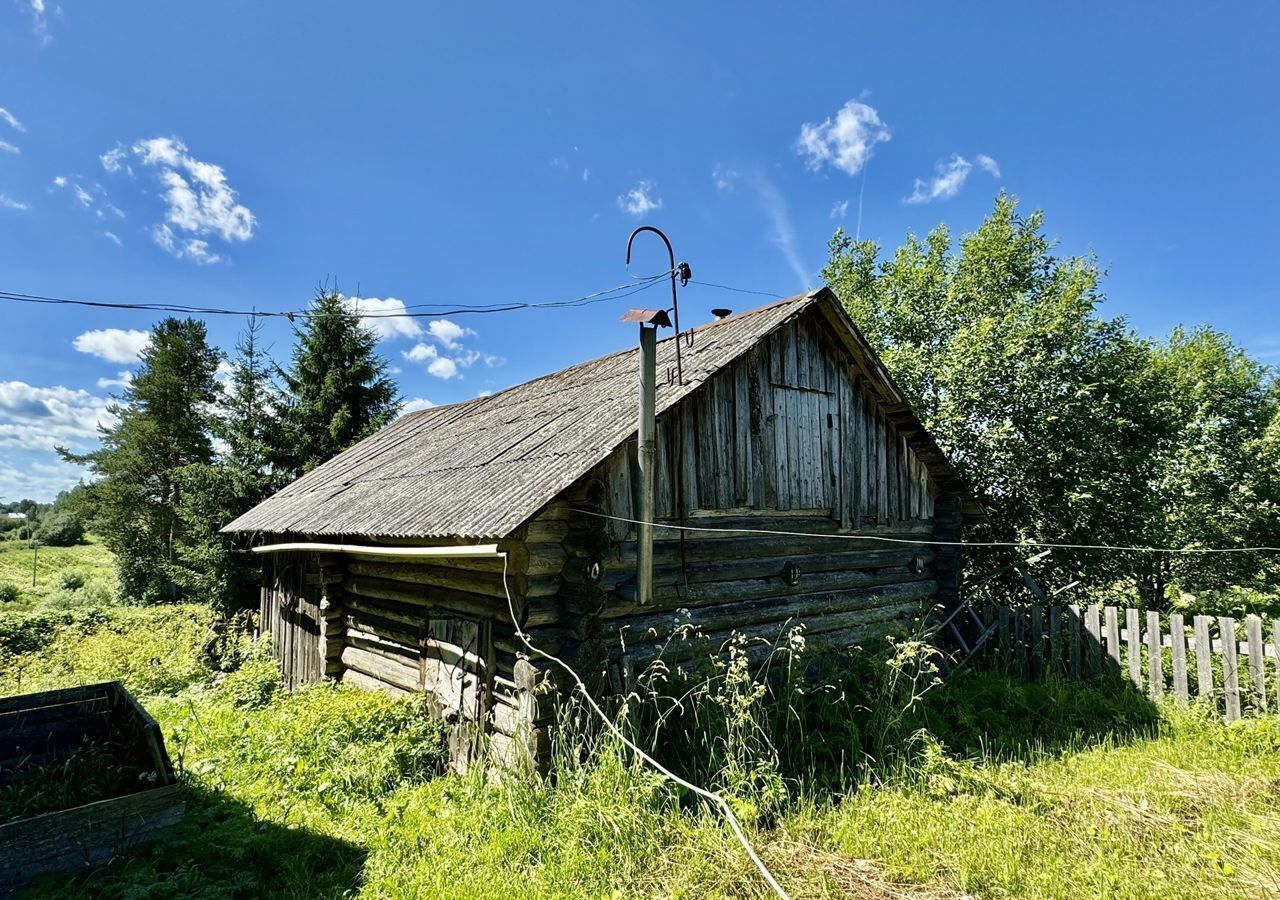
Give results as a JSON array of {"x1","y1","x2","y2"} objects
[{"x1": 920, "y1": 670, "x2": 1160, "y2": 760}]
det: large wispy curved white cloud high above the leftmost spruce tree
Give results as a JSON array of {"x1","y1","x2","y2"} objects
[{"x1": 114, "y1": 137, "x2": 257, "y2": 265}]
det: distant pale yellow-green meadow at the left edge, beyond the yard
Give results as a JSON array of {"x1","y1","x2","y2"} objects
[{"x1": 0, "y1": 538, "x2": 115, "y2": 609}]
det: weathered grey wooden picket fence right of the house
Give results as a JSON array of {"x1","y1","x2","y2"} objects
[{"x1": 979, "y1": 604, "x2": 1280, "y2": 722}]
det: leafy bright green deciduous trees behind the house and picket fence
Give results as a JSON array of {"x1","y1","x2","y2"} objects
[{"x1": 823, "y1": 196, "x2": 1276, "y2": 603}]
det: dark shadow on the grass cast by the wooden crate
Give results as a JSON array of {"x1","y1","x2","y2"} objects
[{"x1": 19, "y1": 782, "x2": 365, "y2": 900}]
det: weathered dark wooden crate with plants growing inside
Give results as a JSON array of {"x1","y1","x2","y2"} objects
[{"x1": 0, "y1": 681, "x2": 186, "y2": 895}]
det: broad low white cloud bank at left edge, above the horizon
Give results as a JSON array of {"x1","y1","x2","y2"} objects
[{"x1": 0, "y1": 382, "x2": 113, "y2": 451}]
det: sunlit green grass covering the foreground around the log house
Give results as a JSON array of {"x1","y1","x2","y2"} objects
[{"x1": 0, "y1": 607, "x2": 1280, "y2": 900}]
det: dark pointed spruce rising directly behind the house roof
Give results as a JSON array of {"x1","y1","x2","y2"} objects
[{"x1": 274, "y1": 291, "x2": 401, "y2": 476}]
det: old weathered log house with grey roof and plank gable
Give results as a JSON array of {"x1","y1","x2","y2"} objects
[{"x1": 225, "y1": 289, "x2": 965, "y2": 766}]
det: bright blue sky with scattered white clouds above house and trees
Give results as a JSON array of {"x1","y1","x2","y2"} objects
[{"x1": 0, "y1": 0, "x2": 1280, "y2": 499}]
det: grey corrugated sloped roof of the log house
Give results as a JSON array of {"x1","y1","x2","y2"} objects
[{"x1": 223, "y1": 288, "x2": 954, "y2": 538}]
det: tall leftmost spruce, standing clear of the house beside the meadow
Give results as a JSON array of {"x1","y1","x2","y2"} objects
[{"x1": 60, "y1": 317, "x2": 220, "y2": 603}]
